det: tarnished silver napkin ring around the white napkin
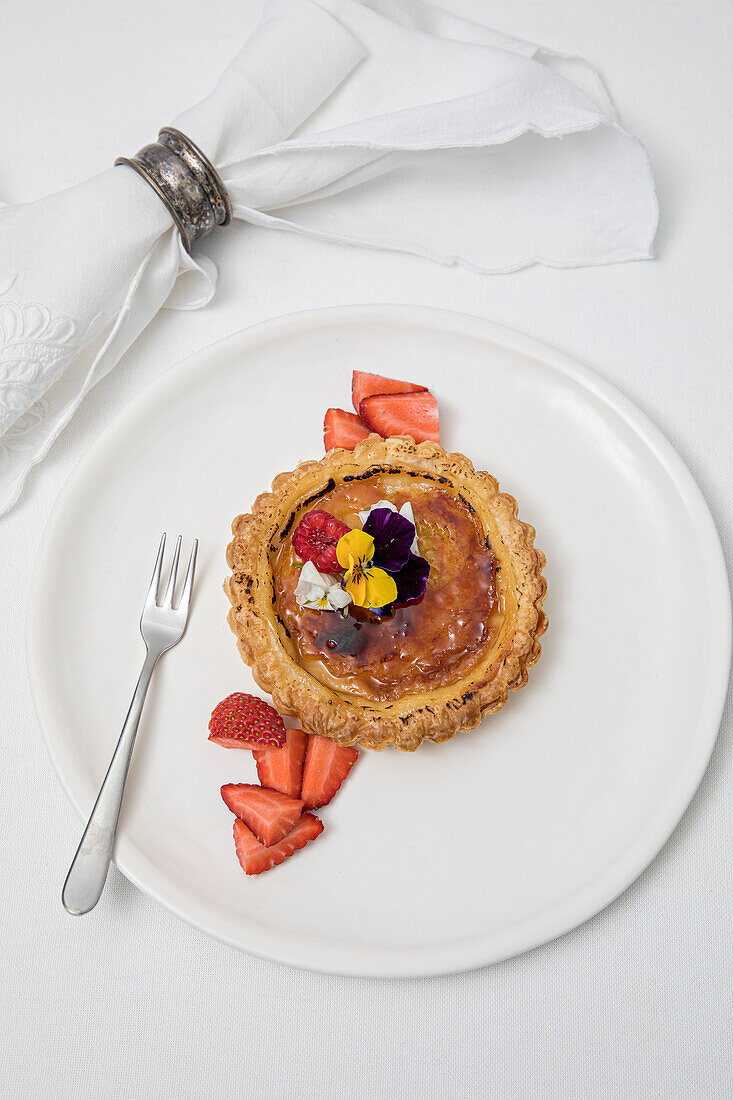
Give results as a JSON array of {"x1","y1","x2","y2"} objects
[{"x1": 114, "y1": 127, "x2": 231, "y2": 252}]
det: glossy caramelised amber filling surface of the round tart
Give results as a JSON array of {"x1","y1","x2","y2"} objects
[{"x1": 273, "y1": 474, "x2": 502, "y2": 703}]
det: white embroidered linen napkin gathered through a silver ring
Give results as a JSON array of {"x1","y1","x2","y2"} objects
[{"x1": 0, "y1": 0, "x2": 657, "y2": 513}]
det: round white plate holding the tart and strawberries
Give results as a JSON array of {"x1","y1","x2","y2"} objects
[{"x1": 28, "y1": 307, "x2": 731, "y2": 976}]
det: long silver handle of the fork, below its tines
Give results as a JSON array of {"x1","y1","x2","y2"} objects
[{"x1": 62, "y1": 650, "x2": 160, "y2": 916}]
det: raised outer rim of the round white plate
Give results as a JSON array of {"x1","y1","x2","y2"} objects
[{"x1": 25, "y1": 304, "x2": 732, "y2": 978}]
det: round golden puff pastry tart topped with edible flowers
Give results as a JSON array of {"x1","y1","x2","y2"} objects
[{"x1": 225, "y1": 436, "x2": 547, "y2": 750}]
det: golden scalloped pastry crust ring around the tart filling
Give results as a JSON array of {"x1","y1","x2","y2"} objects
[{"x1": 225, "y1": 436, "x2": 547, "y2": 751}]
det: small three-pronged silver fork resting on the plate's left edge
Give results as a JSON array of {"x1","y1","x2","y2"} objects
[{"x1": 62, "y1": 535, "x2": 198, "y2": 916}]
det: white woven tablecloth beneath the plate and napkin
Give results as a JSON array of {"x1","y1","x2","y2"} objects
[{"x1": 0, "y1": 0, "x2": 733, "y2": 1100}]
